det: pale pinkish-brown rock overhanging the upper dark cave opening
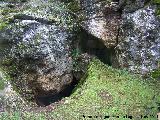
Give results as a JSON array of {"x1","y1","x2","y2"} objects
[{"x1": 80, "y1": 0, "x2": 120, "y2": 48}]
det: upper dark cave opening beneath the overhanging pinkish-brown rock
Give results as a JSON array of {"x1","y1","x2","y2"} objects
[{"x1": 78, "y1": 29, "x2": 116, "y2": 66}]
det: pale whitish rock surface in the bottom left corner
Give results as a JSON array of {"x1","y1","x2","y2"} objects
[{"x1": 0, "y1": 71, "x2": 31, "y2": 113}]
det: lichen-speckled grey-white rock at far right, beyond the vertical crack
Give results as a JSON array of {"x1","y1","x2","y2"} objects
[{"x1": 117, "y1": 6, "x2": 160, "y2": 75}]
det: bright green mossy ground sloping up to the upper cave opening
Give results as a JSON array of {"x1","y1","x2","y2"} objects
[{"x1": 1, "y1": 59, "x2": 160, "y2": 120}]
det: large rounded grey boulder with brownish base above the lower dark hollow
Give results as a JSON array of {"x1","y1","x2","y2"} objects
[{"x1": 0, "y1": 0, "x2": 73, "y2": 96}]
